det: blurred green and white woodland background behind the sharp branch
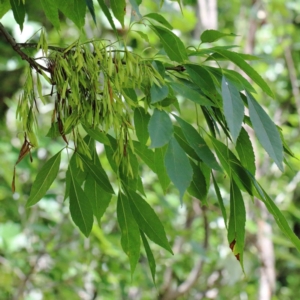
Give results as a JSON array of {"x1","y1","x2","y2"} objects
[{"x1": 0, "y1": 0, "x2": 300, "y2": 300}]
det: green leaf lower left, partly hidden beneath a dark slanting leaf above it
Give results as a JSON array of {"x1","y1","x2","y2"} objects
[{"x1": 84, "y1": 174, "x2": 112, "y2": 226}]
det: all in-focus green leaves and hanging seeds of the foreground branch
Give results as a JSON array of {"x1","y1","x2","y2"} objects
[{"x1": 0, "y1": 0, "x2": 300, "y2": 281}]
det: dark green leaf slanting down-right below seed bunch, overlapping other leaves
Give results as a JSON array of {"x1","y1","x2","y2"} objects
[{"x1": 76, "y1": 152, "x2": 114, "y2": 194}]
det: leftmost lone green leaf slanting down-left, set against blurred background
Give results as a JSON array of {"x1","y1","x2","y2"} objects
[{"x1": 26, "y1": 151, "x2": 61, "y2": 207}]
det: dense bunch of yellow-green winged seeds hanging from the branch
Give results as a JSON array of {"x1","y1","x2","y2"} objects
[{"x1": 17, "y1": 34, "x2": 163, "y2": 173}]
